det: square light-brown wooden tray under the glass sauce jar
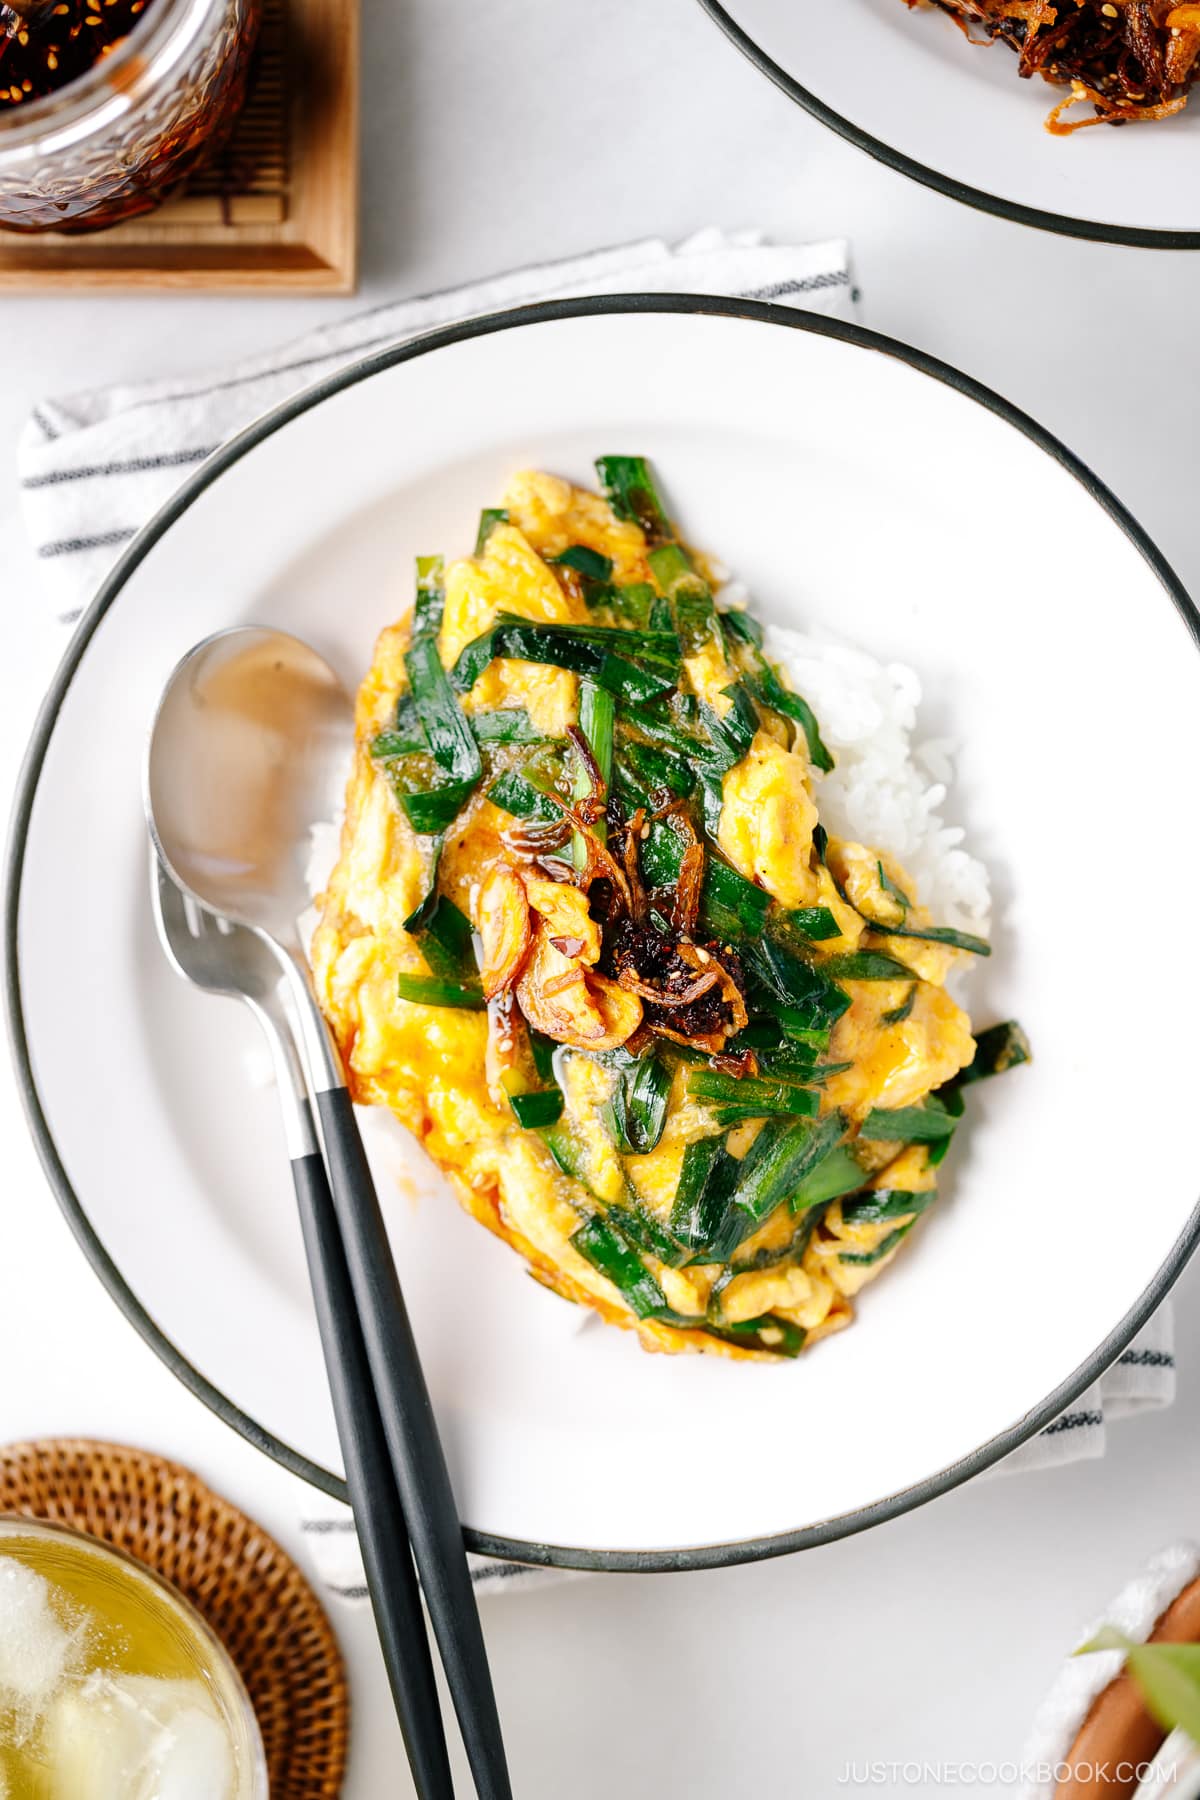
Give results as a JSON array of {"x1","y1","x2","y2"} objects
[{"x1": 0, "y1": 0, "x2": 358, "y2": 293}]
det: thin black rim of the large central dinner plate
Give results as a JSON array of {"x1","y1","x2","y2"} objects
[{"x1": 4, "y1": 293, "x2": 1200, "y2": 1573}]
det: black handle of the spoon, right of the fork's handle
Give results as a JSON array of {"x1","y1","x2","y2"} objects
[{"x1": 315, "y1": 1087, "x2": 513, "y2": 1800}]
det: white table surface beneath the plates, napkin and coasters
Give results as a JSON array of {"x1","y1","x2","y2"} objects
[{"x1": 0, "y1": 0, "x2": 1200, "y2": 1800}]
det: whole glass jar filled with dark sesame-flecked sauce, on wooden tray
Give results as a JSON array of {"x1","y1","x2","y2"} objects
[{"x1": 0, "y1": 0, "x2": 261, "y2": 232}]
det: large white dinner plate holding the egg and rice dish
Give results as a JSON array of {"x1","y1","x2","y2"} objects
[{"x1": 7, "y1": 297, "x2": 1200, "y2": 1568}]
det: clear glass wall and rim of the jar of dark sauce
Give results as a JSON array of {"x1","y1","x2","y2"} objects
[{"x1": 0, "y1": 0, "x2": 261, "y2": 232}]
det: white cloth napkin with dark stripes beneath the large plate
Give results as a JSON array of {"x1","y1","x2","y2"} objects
[{"x1": 18, "y1": 229, "x2": 1175, "y2": 1602}]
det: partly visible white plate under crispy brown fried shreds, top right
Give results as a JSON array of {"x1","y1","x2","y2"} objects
[{"x1": 700, "y1": 0, "x2": 1200, "y2": 250}]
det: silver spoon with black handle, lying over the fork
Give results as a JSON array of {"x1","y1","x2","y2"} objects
[{"x1": 144, "y1": 626, "x2": 511, "y2": 1800}]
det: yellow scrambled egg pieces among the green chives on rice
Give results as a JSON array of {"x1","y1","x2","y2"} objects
[{"x1": 313, "y1": 473, "x2": 975, "y2": 1355}]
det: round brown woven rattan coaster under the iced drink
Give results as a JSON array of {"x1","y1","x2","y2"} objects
[{"x1": 0, "y1": 1438, "x2": 349, "y2": 1800}]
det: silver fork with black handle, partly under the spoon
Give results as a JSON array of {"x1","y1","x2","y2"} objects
[{"x1": 149, "y1": 850, "x2": 453, "y2": 1800}]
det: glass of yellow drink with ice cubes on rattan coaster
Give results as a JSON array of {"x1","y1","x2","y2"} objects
[{"x1": 0, "y1": 1517, "x2": 266, "y2": 1800}]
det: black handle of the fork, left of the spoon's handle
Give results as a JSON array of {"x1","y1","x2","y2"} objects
[{"x1": 291, "y1": 1152, "x2": 453, "y2": 1800}]
